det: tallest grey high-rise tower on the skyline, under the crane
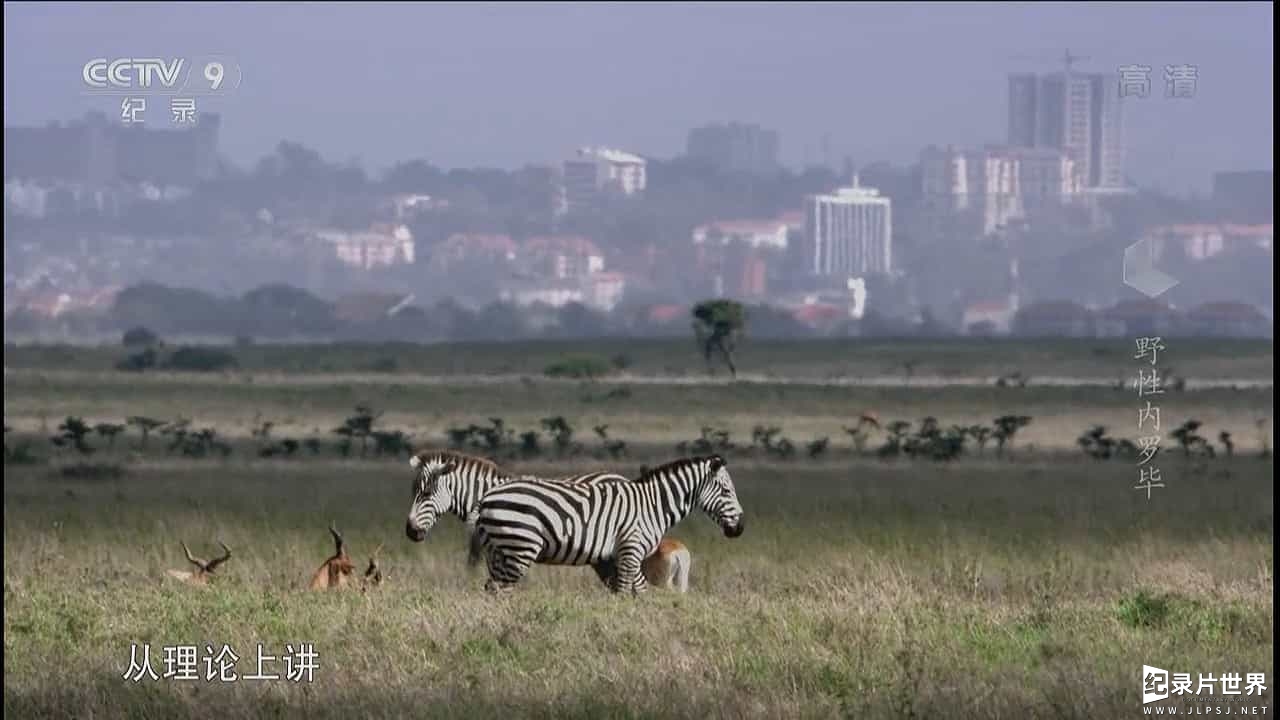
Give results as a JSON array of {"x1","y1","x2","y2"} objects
[{"x1": 1009, "y1": 72, "x2": 1124, "y2": 187}]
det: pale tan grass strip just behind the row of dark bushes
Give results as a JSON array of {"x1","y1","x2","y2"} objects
[{"x1": 4, "y1": 372, "x2": 1274, "y2": 455}]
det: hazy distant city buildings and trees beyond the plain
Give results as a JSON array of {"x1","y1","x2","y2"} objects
[{"x1": 4, "y1": 55, "x2": 1274, "y2": 336}]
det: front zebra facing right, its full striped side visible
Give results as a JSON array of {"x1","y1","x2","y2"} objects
[{"x1": 467, "y1": 455, "x2": 745, "y2": 594}]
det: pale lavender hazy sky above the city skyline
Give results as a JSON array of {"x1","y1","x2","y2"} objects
[{"x1": 4, "y1": 3, "x2": 1274, "y2": 191}]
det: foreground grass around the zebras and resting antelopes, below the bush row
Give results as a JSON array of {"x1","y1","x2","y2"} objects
[{"x1": 4, "y1": 459, "x2": 1274, "y2": 717}]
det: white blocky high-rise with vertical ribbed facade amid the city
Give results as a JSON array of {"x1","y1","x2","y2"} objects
[{"x1": 805, "y1": 176, "x2": 893, "y2": 277}]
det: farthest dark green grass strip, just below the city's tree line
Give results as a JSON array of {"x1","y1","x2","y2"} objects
[{"x1": 4, "y1": 336, "x2": 1274, "y2": 380}]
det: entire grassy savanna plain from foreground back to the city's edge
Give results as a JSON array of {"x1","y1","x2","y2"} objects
[{"x1": 4, "y1": 345, "x2": 1275, "y2": 719}]
